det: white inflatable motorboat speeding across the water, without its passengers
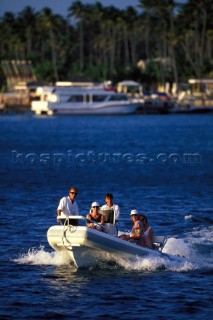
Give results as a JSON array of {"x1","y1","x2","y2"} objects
[{"x1": 47, "y1": 216, "x2": 183, "y2": 268}]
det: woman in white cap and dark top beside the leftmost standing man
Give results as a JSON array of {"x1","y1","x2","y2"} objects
[{"x1": 86, "y1": 201, "x2": 105, "y2": 231}]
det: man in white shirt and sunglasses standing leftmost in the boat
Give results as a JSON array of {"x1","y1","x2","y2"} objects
[{"x1": 57, "y1": 187, "x2": 79, "y2": 225}]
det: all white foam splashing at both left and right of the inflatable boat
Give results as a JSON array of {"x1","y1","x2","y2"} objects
[{"x1": 13, "y1": 227, "x2": 213, "y2": 272}]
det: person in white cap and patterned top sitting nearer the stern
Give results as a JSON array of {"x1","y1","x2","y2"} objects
[{"x1": 119, "y1": 209, "x2": 143, "y2": 245}]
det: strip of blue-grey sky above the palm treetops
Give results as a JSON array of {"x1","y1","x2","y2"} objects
[{"x1": 0, "y1": 0, "x2": 142, "y2": 17}]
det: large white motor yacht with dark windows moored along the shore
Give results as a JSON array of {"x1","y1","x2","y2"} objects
[{"x1": 31, "y1": 86, "x2": 138, "y2": 115}]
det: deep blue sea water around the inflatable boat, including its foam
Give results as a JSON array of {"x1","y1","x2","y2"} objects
[{"x1": 0, "y1": 115, "x2": 213, "y2": 319}]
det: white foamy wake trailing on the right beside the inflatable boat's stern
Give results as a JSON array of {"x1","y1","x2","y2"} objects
[{"x1": 116, "y1": 228, "x2": 213, "y2": 272}]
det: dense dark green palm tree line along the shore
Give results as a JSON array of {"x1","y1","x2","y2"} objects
[{"x1": 0, "y1": 0, "x2": 213, "y2": 90}]
